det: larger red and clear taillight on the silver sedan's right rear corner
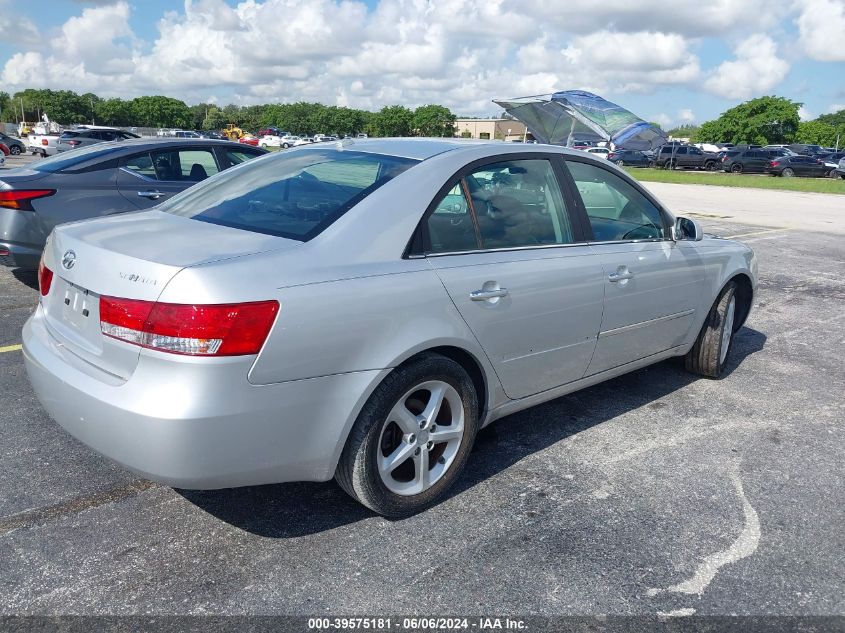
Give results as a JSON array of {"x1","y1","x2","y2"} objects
[{"x1": 100, "y1": 296, "x2": 279, "y2": 356}]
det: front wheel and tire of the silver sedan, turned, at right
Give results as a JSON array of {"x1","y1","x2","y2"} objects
[{"x1": 684, "y1": 281, "x2": 736, "y2": 378}]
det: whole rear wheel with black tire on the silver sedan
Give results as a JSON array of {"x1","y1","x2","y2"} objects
[{"x1": 335, "y1": 354, "x2": 479, "y2": 518}]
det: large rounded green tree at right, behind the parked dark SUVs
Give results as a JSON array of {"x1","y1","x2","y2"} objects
[{"x1": 693, "y1": 97, "x2": 802, "y2": 145}]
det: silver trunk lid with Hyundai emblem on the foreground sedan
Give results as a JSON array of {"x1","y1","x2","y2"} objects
[{"x1": 41, "y1": 211, "x2": 298, "y2": 380}]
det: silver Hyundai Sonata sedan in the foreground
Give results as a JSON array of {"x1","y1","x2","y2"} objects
[{"x1": 23, "y1": 139, "x2": 757, "y2": 516}]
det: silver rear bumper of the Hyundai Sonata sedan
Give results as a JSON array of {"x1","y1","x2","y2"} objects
[{"x1": 23, "y1": 308, "x2": 381, "y2": 489}]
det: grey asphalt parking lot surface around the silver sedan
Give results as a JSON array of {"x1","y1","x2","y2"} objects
[{"x1": 0, "y1": 199, "x2": 845, "y2": 615}]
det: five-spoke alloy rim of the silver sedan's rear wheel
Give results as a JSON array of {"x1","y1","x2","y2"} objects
[{"x1": 376, "y1": 380, "x2": 464, "y2": 495}]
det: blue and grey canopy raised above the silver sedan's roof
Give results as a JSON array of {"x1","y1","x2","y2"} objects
[{"x1": 493, "y1": 90, "x2": 667, "y2": 150}]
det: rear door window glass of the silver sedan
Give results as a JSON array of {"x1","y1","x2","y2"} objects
[{"x1": 427, "y1": 159, "x2": 573, "y2": 253}]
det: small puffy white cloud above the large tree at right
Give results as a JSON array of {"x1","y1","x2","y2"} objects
[{"x1": 704, "y1": 33, "x2": 789, "y2": 99}]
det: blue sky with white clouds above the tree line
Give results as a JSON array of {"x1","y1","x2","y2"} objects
[{"x1": 0, "y1": 0, "x2": 845, "y2": 128}]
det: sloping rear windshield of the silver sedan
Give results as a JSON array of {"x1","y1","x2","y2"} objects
[{"x1": 158, "y1": 148, "x2": 419, "y2": 242}]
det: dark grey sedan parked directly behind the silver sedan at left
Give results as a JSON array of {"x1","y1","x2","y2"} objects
[{"x1": 0, "y1": 138, "x2": 267, "y2": 268}]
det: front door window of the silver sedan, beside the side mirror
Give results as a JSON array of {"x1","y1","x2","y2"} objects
[{"x1": 566, "y1": 160, "x2": 665, "y2": 242}]
